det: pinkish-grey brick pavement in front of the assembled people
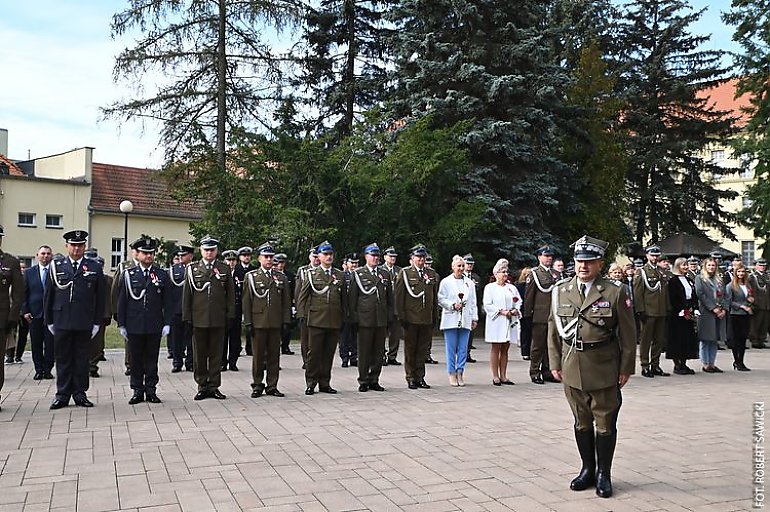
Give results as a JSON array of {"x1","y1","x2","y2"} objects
[{"x1": 0, "y1": 342, "x2": 770, "y2": 512}]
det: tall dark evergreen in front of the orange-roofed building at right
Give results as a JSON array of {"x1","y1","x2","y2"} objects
[{"x1": 619, "y1": 0, "x2": 735, "y2": 242}]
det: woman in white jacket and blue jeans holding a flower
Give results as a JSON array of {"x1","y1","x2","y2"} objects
[{"x1": 438, "y1": 256, "x2": 479, "y2": 386}]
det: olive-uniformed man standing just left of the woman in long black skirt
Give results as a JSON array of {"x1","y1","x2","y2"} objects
[{"x1": 634, "y1": 245, "x2": 671, "y2": 378}]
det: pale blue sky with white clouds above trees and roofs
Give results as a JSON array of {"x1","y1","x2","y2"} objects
[{"x1": 0, "y1": 0, "x2": 735, "y2": 167}]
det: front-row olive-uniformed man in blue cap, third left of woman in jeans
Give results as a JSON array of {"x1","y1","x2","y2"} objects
[{"x1": 297, "y1": 241, "x2": 347, "y2": 395}]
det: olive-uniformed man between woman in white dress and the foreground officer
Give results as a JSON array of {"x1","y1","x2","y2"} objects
[{"x1": 522, "y1": 245, "x2": 557, "y2": 384}]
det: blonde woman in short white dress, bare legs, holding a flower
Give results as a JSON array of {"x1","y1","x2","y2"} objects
[{"x1": 484, "y1": 258, "x2": 521, "y2": 386}]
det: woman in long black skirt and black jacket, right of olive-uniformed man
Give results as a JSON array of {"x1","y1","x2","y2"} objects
[{"x1": 666, "y1": 258, "x2": 698, "y2": 375}]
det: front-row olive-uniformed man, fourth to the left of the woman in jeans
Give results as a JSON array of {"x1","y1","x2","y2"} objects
[{"x1": 243, "y1": 242, "x2": 291, "y2": 398}]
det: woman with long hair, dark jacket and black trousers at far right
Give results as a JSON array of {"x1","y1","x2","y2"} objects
[{"x1": 725, "y1": 263, "x2": 754, "y2": 372}]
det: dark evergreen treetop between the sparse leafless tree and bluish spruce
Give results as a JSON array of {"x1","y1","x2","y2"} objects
[{"x1": 297, "y1": 0, "x2": 392, "y2": 141}]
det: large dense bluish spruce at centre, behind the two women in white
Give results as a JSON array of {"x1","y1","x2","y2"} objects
[{"x1": 384, "y1": 0, "x2": 569, "y2": 261}]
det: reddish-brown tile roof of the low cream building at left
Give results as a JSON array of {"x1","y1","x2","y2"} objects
[{"x1": 91, "y1": 162, "x2": 202, "y2": 219}]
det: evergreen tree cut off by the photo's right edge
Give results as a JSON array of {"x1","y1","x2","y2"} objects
[{"x1": 723, "y1": 0, "x2": 770, "y2": 257}]
